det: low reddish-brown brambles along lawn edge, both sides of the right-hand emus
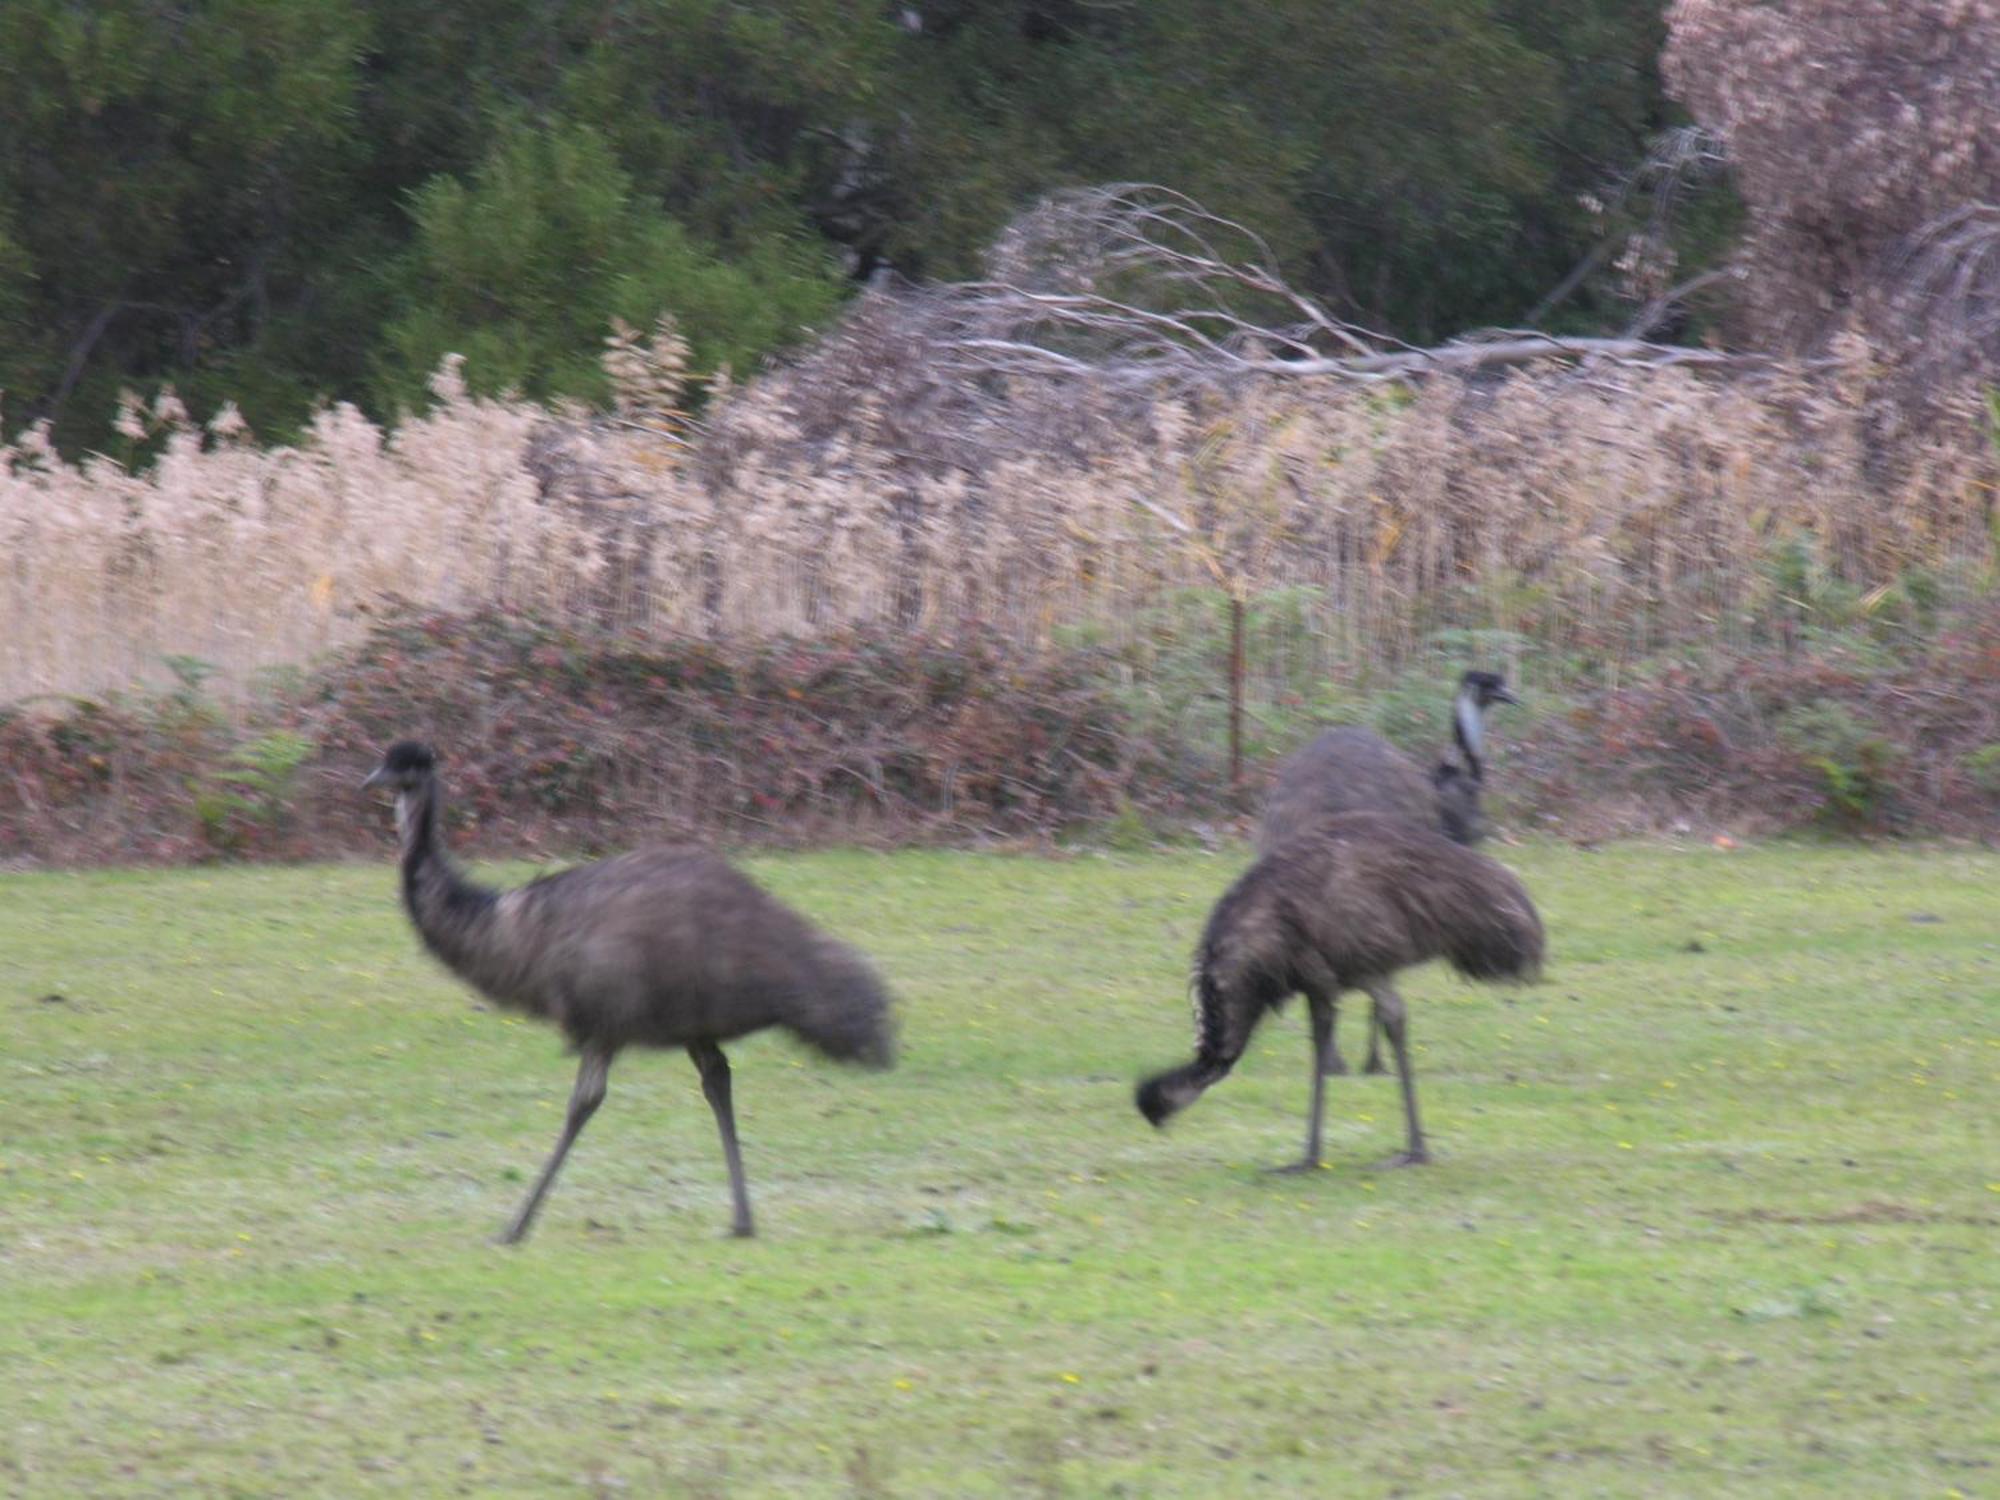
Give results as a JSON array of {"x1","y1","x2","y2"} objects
[{"x1": 0, "y1": 596, "x2": 2000, "y2": 862}]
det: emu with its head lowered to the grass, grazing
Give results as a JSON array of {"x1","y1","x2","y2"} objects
[{"x1": 1136, "y1": 812, "x2": 1542, "y2": 1170}]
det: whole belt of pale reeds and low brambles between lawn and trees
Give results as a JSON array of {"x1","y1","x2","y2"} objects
[{"x1": 0, "y1": 294, "x2": 2000, "y2": 860}]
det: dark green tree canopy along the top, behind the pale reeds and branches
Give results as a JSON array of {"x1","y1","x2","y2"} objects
[{"x1": 0, "y1": 0, "x2": 1704, "y2": 450}]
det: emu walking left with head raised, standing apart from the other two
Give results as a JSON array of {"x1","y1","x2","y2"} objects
[{"x1": 362, "y1": 740, "x2": 892, "y2": 1244}]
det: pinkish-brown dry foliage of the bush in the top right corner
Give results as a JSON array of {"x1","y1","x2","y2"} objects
[{"x1": 1662, "y1": 0, "x2": 2000, "y2": 402}]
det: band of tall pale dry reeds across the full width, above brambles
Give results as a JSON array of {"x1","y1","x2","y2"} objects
[{"x1": 0, "y1": 322, "x2": 1996, "y2": 702}]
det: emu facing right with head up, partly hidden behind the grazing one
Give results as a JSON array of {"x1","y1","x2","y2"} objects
[{"x1": 1256, "y1": 672, "x2": 1520, "y2": 1074}]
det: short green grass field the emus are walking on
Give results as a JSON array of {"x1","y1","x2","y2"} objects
[{"x1": 0, "y1": 846, "x2": 2000, "y2": 1496}]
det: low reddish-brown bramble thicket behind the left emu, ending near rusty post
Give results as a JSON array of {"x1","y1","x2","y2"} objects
[{"x1": 0, "y1": 610, "x2": 1152, "y2": 862}]
